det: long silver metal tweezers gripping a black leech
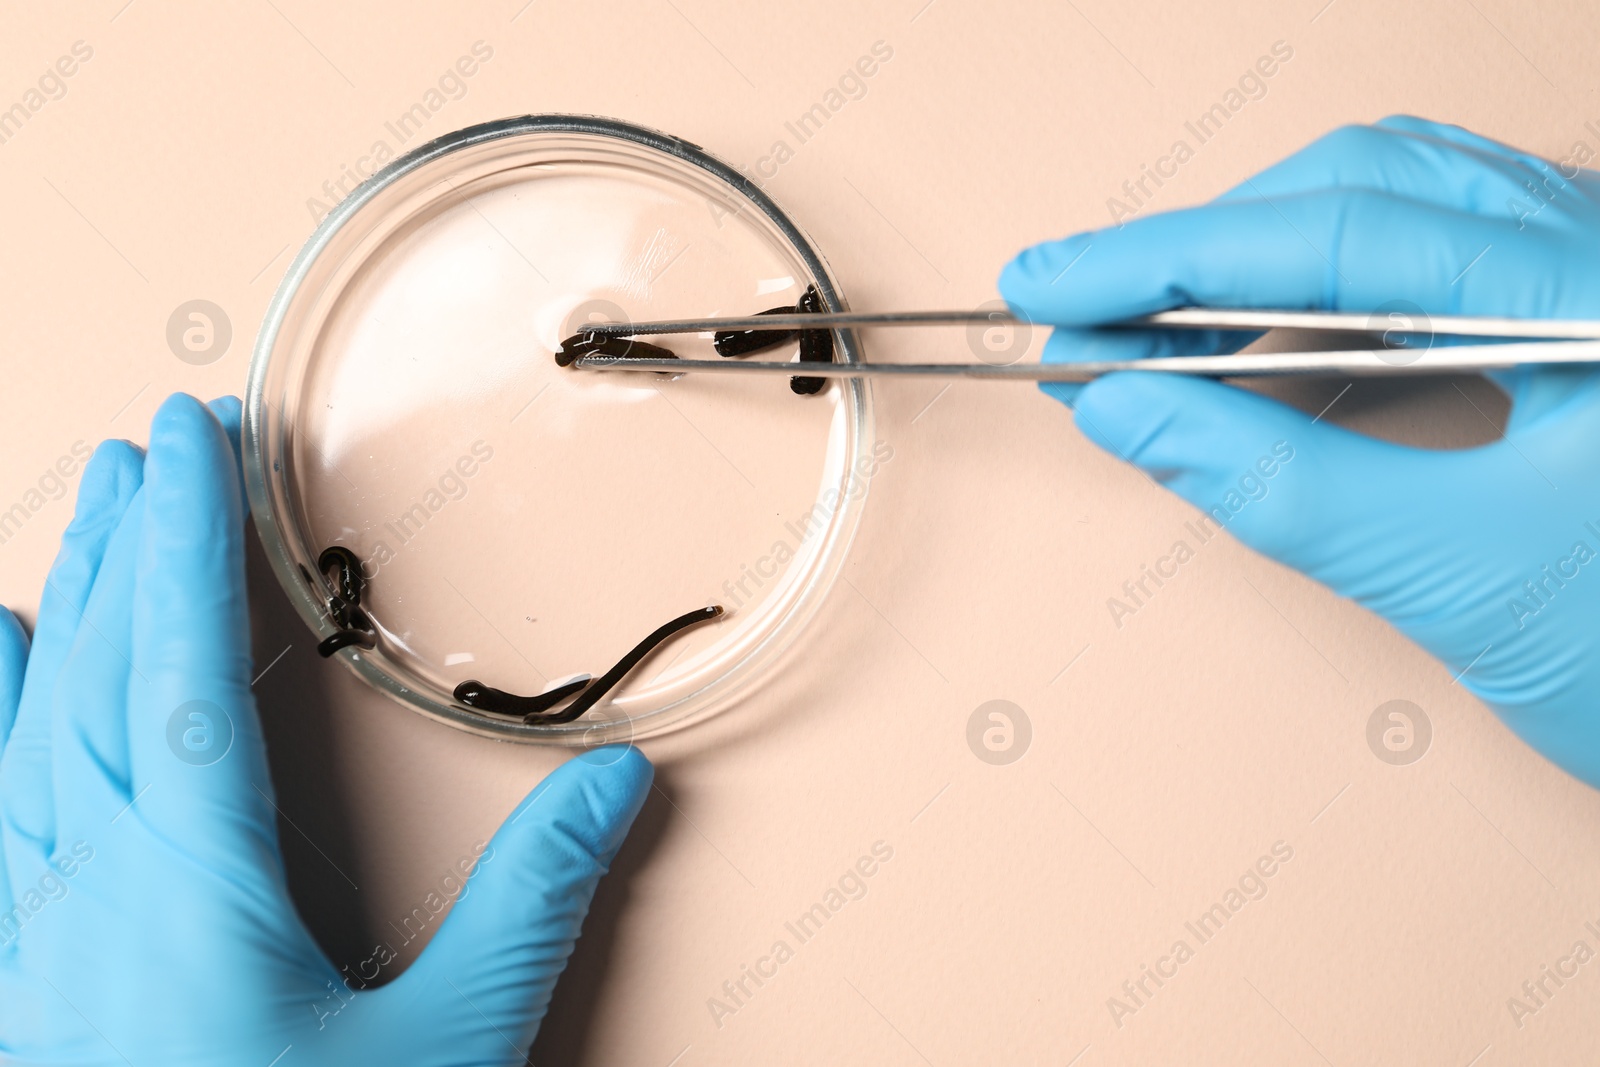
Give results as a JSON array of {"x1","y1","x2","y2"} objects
[{"x1": 565, "y1": 307, "x2": 1600, "y2": 382}]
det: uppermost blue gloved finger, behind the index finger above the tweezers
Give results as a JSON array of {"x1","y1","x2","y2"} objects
[{"x1": 1214, "y1": 120, "x2": 1560, "y2": 219}]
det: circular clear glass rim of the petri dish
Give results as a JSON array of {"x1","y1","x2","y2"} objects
[{"x1": 242, "y1": 108, "x2": 872, "y2": 747}]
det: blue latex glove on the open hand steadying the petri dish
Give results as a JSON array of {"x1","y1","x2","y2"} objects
[{"x1": 0, "y1": 397, "x2": 651, "y2": 1067}]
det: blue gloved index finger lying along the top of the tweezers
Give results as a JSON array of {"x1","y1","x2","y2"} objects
[{"x1": 1000, "y1": 190, "x2": 1536, "y2": 326}]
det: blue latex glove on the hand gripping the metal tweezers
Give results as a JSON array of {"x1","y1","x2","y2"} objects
[{"x1": 1000, "y1": 117, "x2": 1600, "y2": 785}]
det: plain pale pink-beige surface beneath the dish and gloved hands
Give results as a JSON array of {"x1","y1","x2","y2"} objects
[{"x1": 0, "y1": 0, "x2": 1600, "y2": 1067}]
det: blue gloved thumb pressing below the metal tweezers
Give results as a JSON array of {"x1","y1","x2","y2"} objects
[{"x1": 1077, "y1": 374, "x2": 1426, "y2": 591}]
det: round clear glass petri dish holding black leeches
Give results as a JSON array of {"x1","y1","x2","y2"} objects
[{"x1": 243, "y1": 115, "x2": 891, "y2": 745}]
